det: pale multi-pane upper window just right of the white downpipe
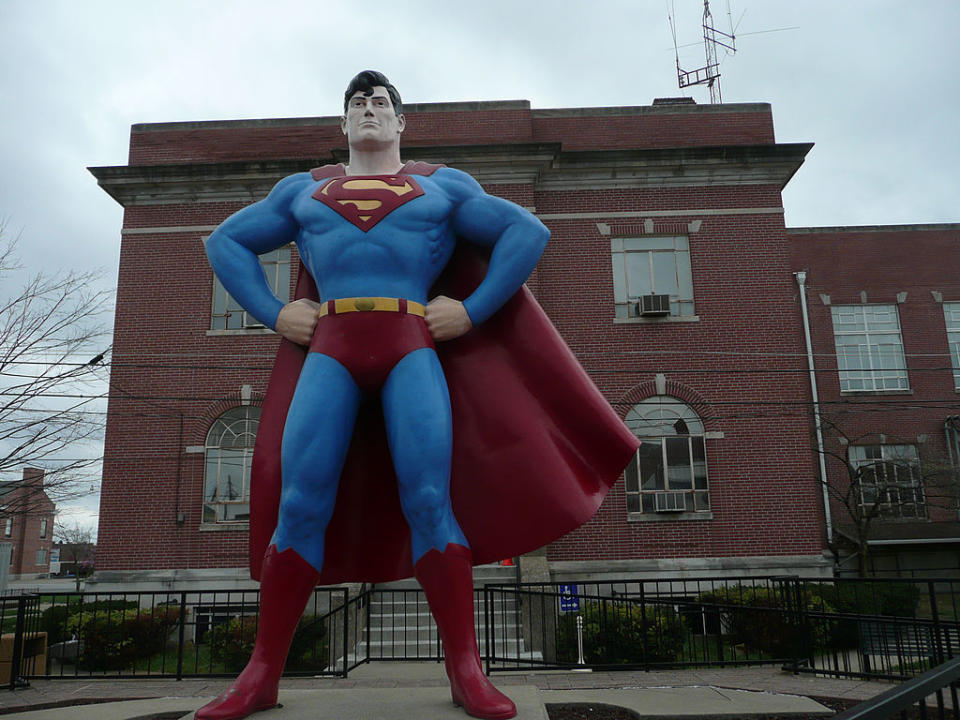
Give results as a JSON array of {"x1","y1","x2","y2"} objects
[{"x1": 831, "y1": 305, "x2": 910, "y2": 391}]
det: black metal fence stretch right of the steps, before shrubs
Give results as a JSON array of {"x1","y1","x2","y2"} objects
[{"x1": 484, "y1": 577, "x2": 960, "y2": 680}]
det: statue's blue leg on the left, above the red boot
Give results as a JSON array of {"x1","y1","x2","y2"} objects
[{"x1": 272, "y1": 353, "x2": 361, "y2": 571}]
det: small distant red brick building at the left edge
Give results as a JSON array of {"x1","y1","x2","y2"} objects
[{"x1": 0, "y1": 468, "x2": 56, "y2": 579}]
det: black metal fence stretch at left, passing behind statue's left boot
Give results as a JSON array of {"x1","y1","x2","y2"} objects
[{"x1": 0, "y1": 588, "x2": 357, "y2": 689}]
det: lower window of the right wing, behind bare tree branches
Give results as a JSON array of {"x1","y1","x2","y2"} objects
[{"x1": 850, "y1": 445, "x2": 927, "y2": 518}]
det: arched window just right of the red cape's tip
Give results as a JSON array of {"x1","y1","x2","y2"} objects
[{"x1": 625, "y1": 395, "x2": 710, "y2": 513}]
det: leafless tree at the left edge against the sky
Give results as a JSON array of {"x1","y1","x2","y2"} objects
[{"x1": 0, "y1": 224, "x2": 112, "y2": 516}]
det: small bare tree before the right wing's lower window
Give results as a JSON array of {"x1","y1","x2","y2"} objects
[{"x1": 820, "y1": 416, "x2": 960, "y2": 575}]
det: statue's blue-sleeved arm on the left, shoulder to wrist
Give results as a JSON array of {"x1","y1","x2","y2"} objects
[{"x1": 206, "y1": 173, "x2": 310, "y2": 330}]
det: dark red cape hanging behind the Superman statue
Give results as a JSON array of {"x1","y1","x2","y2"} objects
[{"x1": 250, "y1": 163, "x2": 639, "y2": 585}]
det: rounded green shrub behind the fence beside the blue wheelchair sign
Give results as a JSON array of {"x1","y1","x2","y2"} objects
[{"x1": 557, "y1": 601, "x2": 686, "y2": 665}]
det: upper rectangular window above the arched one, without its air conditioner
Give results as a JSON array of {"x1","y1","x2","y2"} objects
[{"x1": 610, "y1": 236, "x2": 694, "y2": 318}]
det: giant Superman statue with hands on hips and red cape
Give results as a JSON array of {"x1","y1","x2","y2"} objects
[{"x1": 196, "y1": 71, "x2": 637, "y2": 720}]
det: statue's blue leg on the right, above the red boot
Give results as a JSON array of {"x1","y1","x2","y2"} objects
[{"x1": 382, "y1": 348, "x2": 469, "y2": 563}]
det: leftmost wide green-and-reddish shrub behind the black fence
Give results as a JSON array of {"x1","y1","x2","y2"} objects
[{"x1": 67, "y1": 605, "x2": 180, "y2": 671}]
